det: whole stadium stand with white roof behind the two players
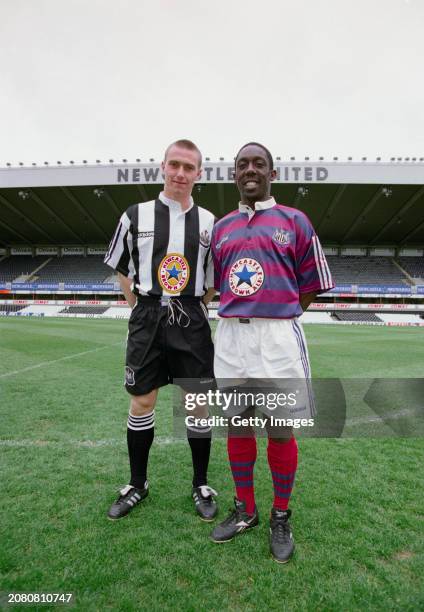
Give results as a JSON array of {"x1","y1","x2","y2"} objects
[{"x1": 0, "y1": 158, "x2": 424, "y2": 325}]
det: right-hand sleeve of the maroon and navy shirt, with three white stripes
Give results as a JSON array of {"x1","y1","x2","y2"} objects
[{"x1": 296, "y1": 216, "x2": 334, "y2": 293}]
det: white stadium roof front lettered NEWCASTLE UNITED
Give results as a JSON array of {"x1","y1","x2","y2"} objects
[{"x1": 0, "y1": 157, "x2": 424, "y2": 188}]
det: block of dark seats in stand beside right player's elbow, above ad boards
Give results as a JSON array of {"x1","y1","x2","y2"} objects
[{"x1": 327, "y1": 255, "x2": 408, "y2": 285}]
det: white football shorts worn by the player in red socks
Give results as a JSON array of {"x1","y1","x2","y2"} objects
[{"x1": 214, "y1": 318, "x2": 315, "y2": 418}]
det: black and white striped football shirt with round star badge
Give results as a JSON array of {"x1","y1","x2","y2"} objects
[{"x1": 105, "y1": 192, "x2": 215, "y2": 297}]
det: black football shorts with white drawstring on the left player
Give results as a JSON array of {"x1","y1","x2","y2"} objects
[{"x1": 125, "y1": 296, "x2": 214, "y2": 395}]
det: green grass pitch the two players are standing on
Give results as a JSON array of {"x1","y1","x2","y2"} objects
[{"x1": 0, "y1": 318, "x2": 424, "y2": 611}]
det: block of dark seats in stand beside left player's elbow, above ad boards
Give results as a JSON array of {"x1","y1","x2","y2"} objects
[{"x1": 31, "y1": 255, "x2": 110, "y2": 283}]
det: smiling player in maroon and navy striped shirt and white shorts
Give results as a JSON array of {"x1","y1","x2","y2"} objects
[{"x1": 211, "y1": 143, "x2": 333, "y2": 563}]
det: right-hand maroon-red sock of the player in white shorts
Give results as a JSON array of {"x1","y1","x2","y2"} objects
[{"x1": 268, "y1": 437, "x2": 297, "y2": 510}]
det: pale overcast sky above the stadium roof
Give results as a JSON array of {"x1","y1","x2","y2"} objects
[{"x1": 0, "y1": 0, "x2": 424, "y2": 166}]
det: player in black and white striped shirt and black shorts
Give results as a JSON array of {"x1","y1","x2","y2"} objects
[{"x1": 105, "y1": 140, "x2": 217, "y2": 521}]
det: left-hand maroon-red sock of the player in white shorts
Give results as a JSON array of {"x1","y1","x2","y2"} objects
[{"x1": 227, "y1": 436, "x2": 256, "y2": 514}]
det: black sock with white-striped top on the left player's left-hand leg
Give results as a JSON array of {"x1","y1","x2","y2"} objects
[{"x1": 127, "y1": 410, "x2": 155, "y2": 489}]
